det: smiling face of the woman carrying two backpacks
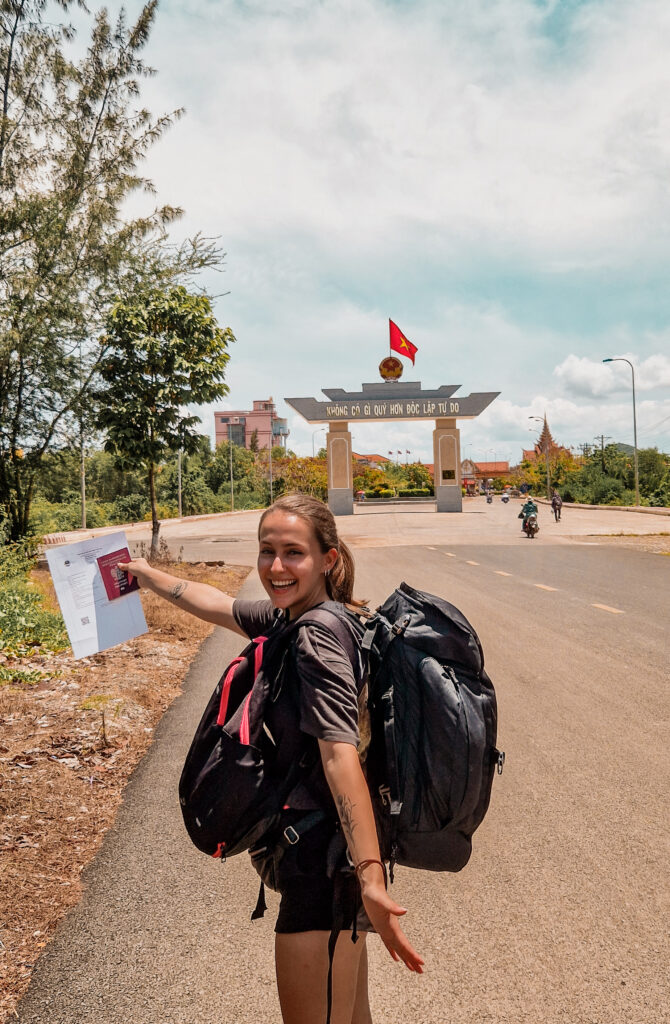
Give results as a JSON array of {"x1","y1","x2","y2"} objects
[{"x1": 258, "y1": 511, "x2": 337, "y2": 618}]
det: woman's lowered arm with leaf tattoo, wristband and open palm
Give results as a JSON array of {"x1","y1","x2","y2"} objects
[{"x1": 319, "y1": 739, "x2": 423, "y2": 974}]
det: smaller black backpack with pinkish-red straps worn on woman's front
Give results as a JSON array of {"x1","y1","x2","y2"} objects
[{"x1": 179, "y1": 601, "x2": 362, "y2": 858}]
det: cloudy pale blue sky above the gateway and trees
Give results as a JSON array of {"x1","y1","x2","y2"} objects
[{"x1": 94, "y1": 0, "x2": 670, "y2": 463}]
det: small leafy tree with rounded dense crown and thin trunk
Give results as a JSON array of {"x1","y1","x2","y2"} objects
[{"x1": 97, "y1": 286, "x2": 235, "y2": 553}]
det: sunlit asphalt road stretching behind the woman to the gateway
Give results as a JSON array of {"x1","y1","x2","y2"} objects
[{"x1": 19, "y1": 503, "x2": 670, "y2": 1024}]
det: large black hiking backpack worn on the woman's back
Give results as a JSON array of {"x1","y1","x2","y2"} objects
[{"x1": 363, "y1": 583, "x2": 505, "y2": 871}]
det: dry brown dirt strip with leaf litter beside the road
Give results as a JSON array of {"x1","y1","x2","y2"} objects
[{"x1": 0, "y1": 563, "x2": 249, "y2": 1024}]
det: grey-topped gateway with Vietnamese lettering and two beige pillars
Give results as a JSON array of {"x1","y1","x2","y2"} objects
[{"x1": 284, "y1": 381, "x2": 500, "y2": 515}]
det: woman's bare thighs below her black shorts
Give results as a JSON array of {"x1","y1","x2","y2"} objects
[{"x1": 275, "y1": 932, "x2": 370, "y2": 1024}]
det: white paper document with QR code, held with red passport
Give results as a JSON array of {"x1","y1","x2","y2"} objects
[{"x1": 46, "y1": 531, "x2": 146, "y2": 657}]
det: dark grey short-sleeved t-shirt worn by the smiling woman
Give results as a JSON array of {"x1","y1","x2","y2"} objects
[{"x1": 233, "y1": 599, "x2": 363, "y2": 810}]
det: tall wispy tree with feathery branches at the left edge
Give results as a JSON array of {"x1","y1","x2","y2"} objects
[{"x1": 0, "y1": 0, "x2": 220, "y2": 539}]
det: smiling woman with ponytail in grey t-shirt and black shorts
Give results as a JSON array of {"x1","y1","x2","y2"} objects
[{"x1": 120, "y1": 495, "x2": 423, "y2": 1024}]
